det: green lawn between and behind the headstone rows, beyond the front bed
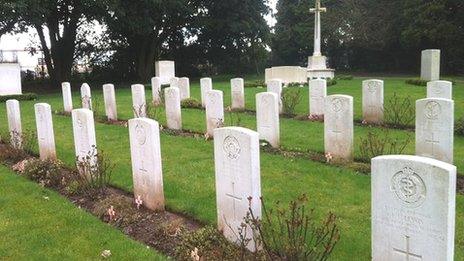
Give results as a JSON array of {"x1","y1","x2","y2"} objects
[{"x1": 0, "y1": 75, "x2": 464, "y2": 260}]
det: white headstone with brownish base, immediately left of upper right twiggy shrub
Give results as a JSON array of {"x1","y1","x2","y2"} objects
[{"x1": 362, "y1": 80, "x2": 384, "y2": 124}]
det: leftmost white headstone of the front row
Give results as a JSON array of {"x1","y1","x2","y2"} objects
[{"x1": 6, "y1": 100, "x2": 23, "y2": 149}]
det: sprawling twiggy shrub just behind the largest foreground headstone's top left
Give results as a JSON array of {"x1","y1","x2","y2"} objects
[{"x1": 359, "y1": 129, "x2": 411, "y2": 162}]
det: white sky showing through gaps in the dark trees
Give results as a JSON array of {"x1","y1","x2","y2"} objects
[{"x1": 0, "y1": 0, "x2": 278, "y2": 67}]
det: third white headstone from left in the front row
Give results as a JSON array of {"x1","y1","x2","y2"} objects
[{"x1": 71, "y1": 109, "x2": 97, "y2": 170}]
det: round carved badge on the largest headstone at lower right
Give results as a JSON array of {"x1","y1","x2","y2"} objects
[{"x1": 391, "y1": 167, "x2": 427, "y2": 208}]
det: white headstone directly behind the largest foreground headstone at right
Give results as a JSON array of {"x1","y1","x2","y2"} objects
[{"x1": 416, "y1": 98, "x2": 454, "y2": 164}]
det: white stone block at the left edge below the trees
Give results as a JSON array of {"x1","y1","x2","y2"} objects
[{"x1": 0, "y1": 63, "x2": 22, "y2": 95}]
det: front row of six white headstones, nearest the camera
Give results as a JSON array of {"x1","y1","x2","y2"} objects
[{"x1": 2, "y1": 95, "x2": 456, "y2": 260}]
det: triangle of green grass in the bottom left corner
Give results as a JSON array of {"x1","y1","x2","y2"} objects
[{"x1": 0, "y1": 166, "x2": 166, "y2": 260}]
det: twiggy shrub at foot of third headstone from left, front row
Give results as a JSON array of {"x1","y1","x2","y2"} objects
[{"x1": 76, "y1": 147, "x2": 114, "y2": 193}]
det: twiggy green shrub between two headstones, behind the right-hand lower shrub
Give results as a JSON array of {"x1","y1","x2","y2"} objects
[{"x1": 384, "y1": 93, "x2": 415, "y2": 128}]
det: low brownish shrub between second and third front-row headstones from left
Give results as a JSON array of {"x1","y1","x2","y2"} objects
[{"x1": 23, "y1": 159, "x2": 62, "y2": 187}]
